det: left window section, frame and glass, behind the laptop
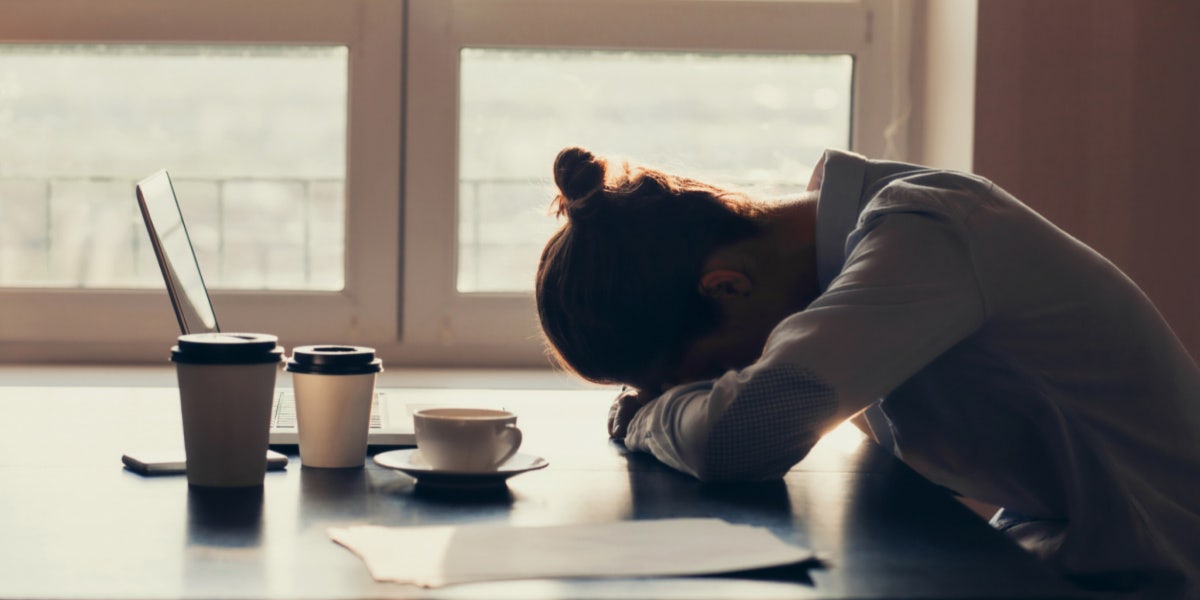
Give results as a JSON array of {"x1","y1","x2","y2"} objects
[{"x1": 0, "y1": 0, "x2": 403, "y2": 361}]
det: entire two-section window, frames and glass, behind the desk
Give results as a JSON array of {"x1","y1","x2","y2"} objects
[{"x1": 0, "y1": 0, "x2": 907, "y2": 366}]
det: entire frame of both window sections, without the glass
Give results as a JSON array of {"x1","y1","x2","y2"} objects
[{"x1": 0, "y1": 0, "x2": 912, "y2": 367}]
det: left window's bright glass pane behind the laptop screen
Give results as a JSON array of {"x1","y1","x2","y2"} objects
[{"x1": 0, "y1": 44, "x2": 348, "y2": 290}]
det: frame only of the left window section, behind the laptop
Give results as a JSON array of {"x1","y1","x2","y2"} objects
[{"x1": 0, "y1": 0, "x2": 404, "y2": 362}]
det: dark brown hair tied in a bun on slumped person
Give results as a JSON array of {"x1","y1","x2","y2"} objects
[{"x1": 536, "y1": 148, "x2": 758, "y2": 388}]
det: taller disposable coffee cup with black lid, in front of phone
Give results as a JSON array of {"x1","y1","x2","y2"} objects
[{"x1": 170, "y1": 334, "x2": 283, "y2": 487}]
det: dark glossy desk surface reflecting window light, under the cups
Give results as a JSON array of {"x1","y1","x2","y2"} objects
[{"x1": 0, "y1": 386, "x2": 1073, "y2": 599}]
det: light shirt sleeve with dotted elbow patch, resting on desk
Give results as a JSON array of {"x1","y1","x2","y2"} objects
[{"x1": 625, "y1": 208, "x2": 986, "y2": 481}]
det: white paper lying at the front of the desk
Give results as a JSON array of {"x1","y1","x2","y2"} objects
[{"x1": 329, "y1": 518, "x2": 812, "y2": 588}]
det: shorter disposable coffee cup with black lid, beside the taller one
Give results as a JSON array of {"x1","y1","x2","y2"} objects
[{"x1": 287, "y1": 344, "x2": 383, "y2": 468}]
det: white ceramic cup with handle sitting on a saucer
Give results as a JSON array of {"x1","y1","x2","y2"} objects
[{"x1": 413, "y1": 408, "x2": 521, "y2": 473}]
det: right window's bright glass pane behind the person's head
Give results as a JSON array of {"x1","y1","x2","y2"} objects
[{"x1": 457, "y1": 48, "x2": 853, "y2": 293}]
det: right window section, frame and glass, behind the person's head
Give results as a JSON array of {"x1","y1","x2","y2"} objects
[{"x1": 402, "y1": 0, "x2": 907, "y2": 364}]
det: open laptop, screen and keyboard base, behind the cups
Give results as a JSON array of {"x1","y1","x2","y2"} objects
[{"x1": 136, "y1": 170, "x2": 416, "y2": 446}]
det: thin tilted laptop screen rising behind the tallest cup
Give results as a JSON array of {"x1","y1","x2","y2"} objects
[{"x1": 137, "y1": 170, "x2": 220, "y2": 334}]
